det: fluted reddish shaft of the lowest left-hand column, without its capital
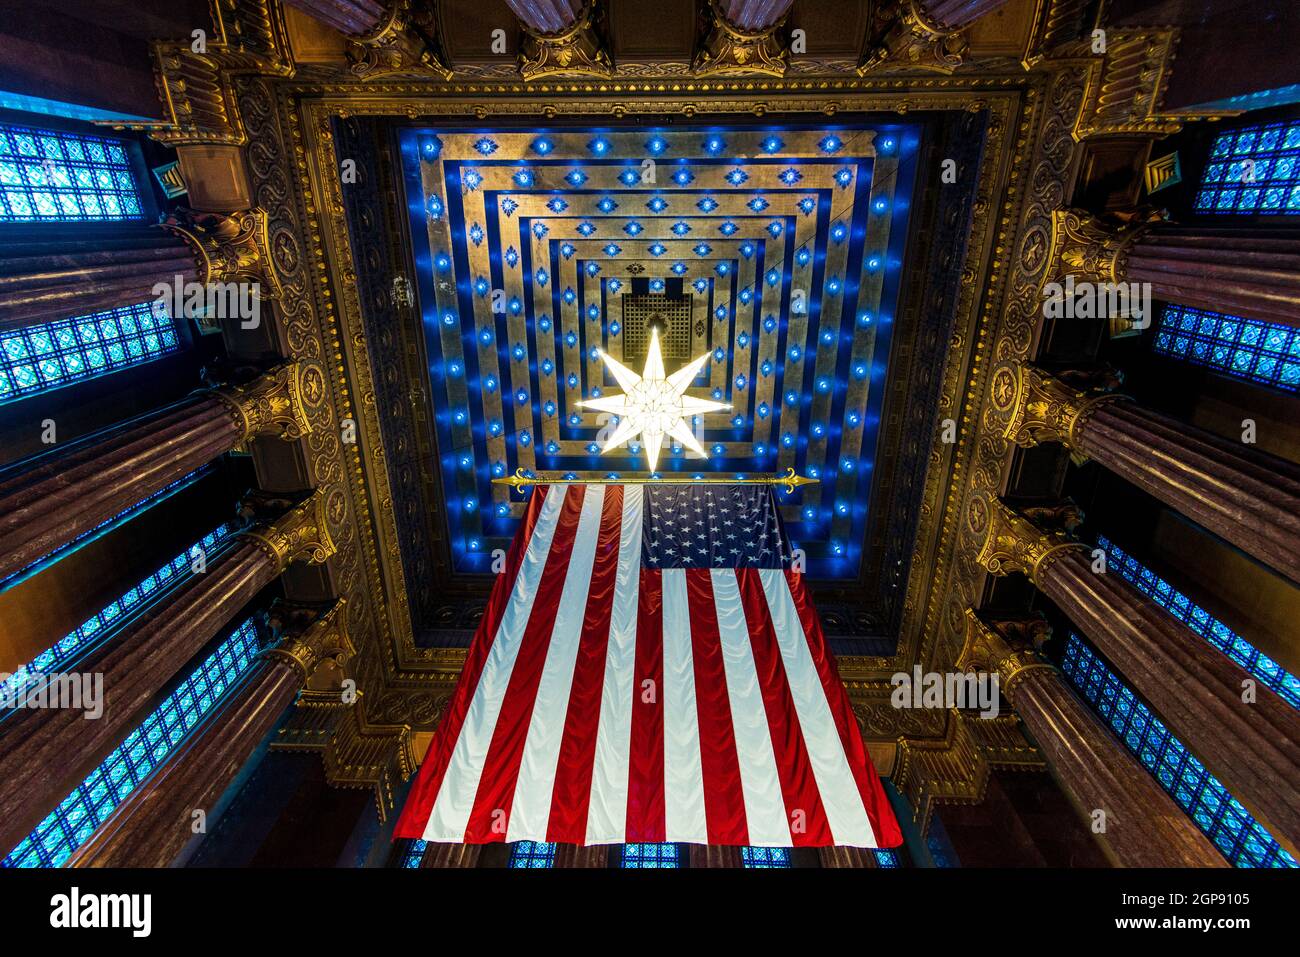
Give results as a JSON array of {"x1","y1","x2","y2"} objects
[{"x1": 65, "y1": 658, "x2": 303, "y2": 867}]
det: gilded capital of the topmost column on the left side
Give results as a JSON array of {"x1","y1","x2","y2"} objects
[{"x1": 161, "y1": 208, "x2": 283, "y2": 299}]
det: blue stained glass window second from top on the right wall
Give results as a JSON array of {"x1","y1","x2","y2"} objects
[{"x1": 1154, "y1": 304, "x2": 1300, "y2": 391}]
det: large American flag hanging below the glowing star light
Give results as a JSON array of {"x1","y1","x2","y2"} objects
[{"x1": 397, "y1": 484, "x2": 902, "y2": 848}]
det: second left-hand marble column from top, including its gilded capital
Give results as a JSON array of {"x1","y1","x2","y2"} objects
[{"x1": 0, "y1": 361, "x2": 325, "y2": 579}]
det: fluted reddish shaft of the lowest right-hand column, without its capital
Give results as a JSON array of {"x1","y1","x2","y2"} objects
[{"x1": 1010, "y1": 668, "x2": 1227, "y2": 867}]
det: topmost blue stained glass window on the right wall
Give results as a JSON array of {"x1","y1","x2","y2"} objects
[{"x1": 1196, "y1": 120, "x2": 1300, "y2": 216}]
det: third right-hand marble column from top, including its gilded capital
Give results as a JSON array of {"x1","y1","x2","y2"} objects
[{"x1": 969, "y1": 499, "x2": 1300, "y2": 853}]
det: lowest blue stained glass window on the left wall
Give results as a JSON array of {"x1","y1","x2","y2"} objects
[{"x1": 0, "y1": 619, "x2": 261, "y2": 867}]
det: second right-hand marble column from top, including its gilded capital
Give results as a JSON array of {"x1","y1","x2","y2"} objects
[{"x1": 991, "y1": 363, "x2": 1300, "y2": 583}]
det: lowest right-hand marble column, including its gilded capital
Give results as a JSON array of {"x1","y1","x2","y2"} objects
[{"x1": 957, "y1": 609, "x2": 1227, "y2": 867}]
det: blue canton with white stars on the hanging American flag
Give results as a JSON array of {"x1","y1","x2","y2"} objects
[{"x1": 641, "y1": 485, "x2": 790, "y2": 568}]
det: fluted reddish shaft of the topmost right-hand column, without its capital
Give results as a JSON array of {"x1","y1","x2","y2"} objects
[{"x1": 1125, "y1": 225, "x2": 1300, "y2": 326}]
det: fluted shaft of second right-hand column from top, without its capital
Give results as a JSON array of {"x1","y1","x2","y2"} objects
[{"x1": 1075, "y1": 402, "x2": 1300, "y2": 583}]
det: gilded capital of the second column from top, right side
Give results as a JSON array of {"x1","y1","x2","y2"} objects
[{"x1": 989, "y1": 360, "x2": 1127, "y2": 451}]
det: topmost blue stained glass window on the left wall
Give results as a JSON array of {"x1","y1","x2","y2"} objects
[{"x1": 0, "y1": 125, "x2": 144, "y2": 222}]
